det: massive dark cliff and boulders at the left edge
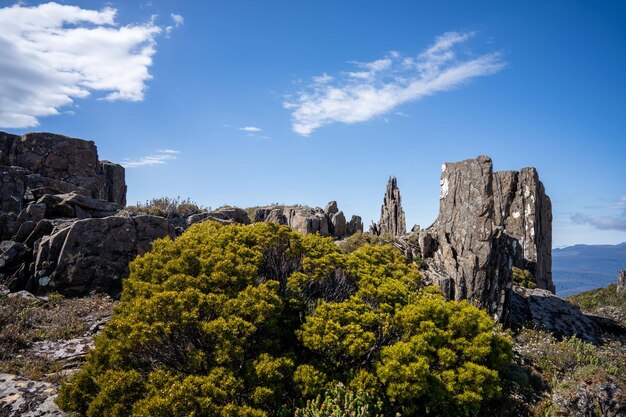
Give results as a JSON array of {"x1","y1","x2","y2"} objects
[{"x1": 0, "y1": 133, "x2": 174, "y2": 294}]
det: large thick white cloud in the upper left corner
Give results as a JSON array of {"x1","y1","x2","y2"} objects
[{"x1": 0, "y1": 3, "x2": 161, "y2": 128}]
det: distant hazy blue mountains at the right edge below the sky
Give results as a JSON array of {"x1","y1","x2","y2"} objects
[{"x1": 552, "y1": 242, "x2": 626, "y2": 297}]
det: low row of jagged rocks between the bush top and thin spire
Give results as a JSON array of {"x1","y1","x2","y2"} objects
[{"x1": 254, "y1": 201, "x2": 363, "y2": 239}]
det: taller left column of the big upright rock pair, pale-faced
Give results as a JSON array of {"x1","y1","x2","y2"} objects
[{"x1": 419, "y1": 156, "x2": 521, "y2": 319}]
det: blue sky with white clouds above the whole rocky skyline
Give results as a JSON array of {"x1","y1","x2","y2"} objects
[{"x1": 0, "y1": 0, "x2": 626, "y2": 246}]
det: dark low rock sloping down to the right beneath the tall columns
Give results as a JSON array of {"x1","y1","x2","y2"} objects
[{"x1": 509, "y1": 286, "x2": 601, "y2": 343}]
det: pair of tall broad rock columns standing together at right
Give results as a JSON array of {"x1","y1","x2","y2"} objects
[{"x1": 418, "y1": 156, "x2": 554, "y2": 320}]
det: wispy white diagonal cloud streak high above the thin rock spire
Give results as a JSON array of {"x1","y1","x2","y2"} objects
[{"x1": 283, "y1": 32, "x2": 505, "y2": 136}]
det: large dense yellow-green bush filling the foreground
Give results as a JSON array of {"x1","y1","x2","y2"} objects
[{"x1": 57, "y1": 222, "x2": 511, "y2": 417}]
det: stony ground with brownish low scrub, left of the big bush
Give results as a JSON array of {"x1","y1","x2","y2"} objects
[{"x1": 0, "y1": 291, "x2": 116, "y2": 417}]
